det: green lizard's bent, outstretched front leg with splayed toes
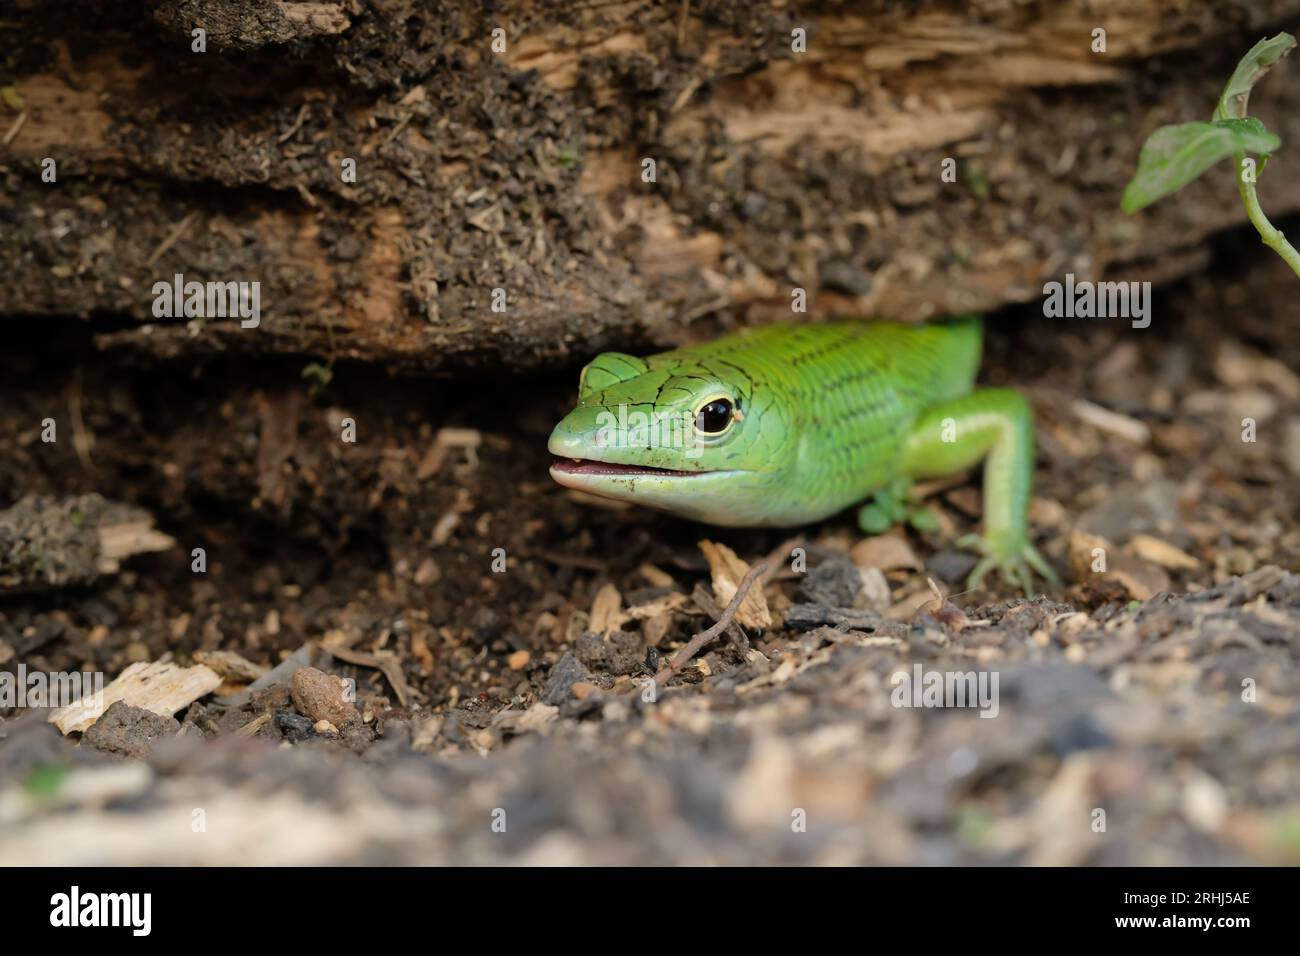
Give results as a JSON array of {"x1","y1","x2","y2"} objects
[{"x1": 902, "y1": 389, "x2": 1058, "y2": 593}]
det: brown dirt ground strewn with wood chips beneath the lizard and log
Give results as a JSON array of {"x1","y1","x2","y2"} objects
[{"x1": 0, "y1": 222, "x2": 1300, "y2": 865}]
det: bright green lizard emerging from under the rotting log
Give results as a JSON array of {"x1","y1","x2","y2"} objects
[{"x1": 549, "y1": 317, "x2": 1056, "y2": 592}]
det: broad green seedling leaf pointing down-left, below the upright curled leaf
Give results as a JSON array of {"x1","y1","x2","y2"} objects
[{"x1": 1122, "y1": 117, "x2": 1282, "y2": 212}]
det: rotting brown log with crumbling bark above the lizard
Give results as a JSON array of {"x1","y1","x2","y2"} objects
[{"x1": 0, "y1": 0, "x2": 1300, "y2": 372}]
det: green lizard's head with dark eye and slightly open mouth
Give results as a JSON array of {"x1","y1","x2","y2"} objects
[{"x1": 547, "y1": 352, "x2": 770, "y2": 524}]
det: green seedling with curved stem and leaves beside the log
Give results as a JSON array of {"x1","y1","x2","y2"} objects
[{"x1": 1122, "y1": 34, "x2": 1300, "y2": 276}]
